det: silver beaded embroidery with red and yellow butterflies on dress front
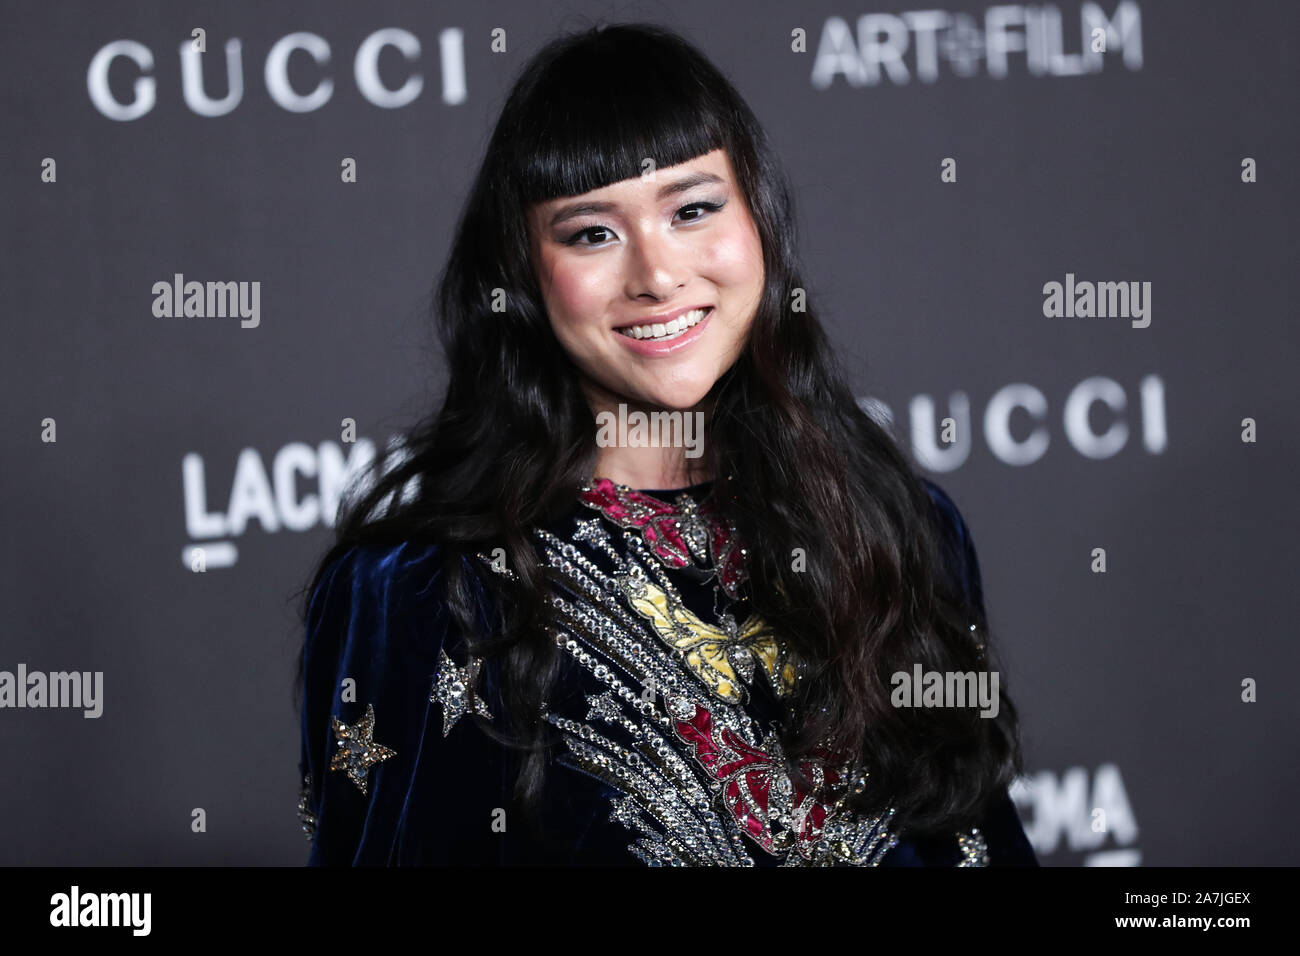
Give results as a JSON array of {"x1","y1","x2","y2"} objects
[{"x1": 478, "y1": 479, "x2": 987, "y2": 866}]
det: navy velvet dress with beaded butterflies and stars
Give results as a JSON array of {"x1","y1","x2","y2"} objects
[{"x1": 299, "y1": 479, "x2": 1037, "y2": 866}]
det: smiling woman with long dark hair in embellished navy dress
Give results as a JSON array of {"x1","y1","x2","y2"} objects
[{"x1": 299, "y1": 25, "x2": 1036, "y2": 866}]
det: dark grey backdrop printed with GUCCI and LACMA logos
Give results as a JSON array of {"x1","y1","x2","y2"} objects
[{"x1": 0, "y1": 0, "x2": 1300, "y2": 866}]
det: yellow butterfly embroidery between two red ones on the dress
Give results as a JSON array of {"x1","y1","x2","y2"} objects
[{"x1": 616, "y1": 575, "x2": 798, "y2": 704}]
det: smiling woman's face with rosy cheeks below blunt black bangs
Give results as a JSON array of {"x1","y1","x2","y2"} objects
[{"x1": 528, "y1": 150, "x2": 763, "y2": 411}]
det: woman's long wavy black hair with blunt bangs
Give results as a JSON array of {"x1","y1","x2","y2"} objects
[{"x1": 299, "y1": 23, "x2": 1022, "y2": 832}]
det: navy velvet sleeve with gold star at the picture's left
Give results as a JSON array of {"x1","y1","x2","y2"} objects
[{"x1": 300, "y1": 542, "x2": 473, "y2": 866}]
